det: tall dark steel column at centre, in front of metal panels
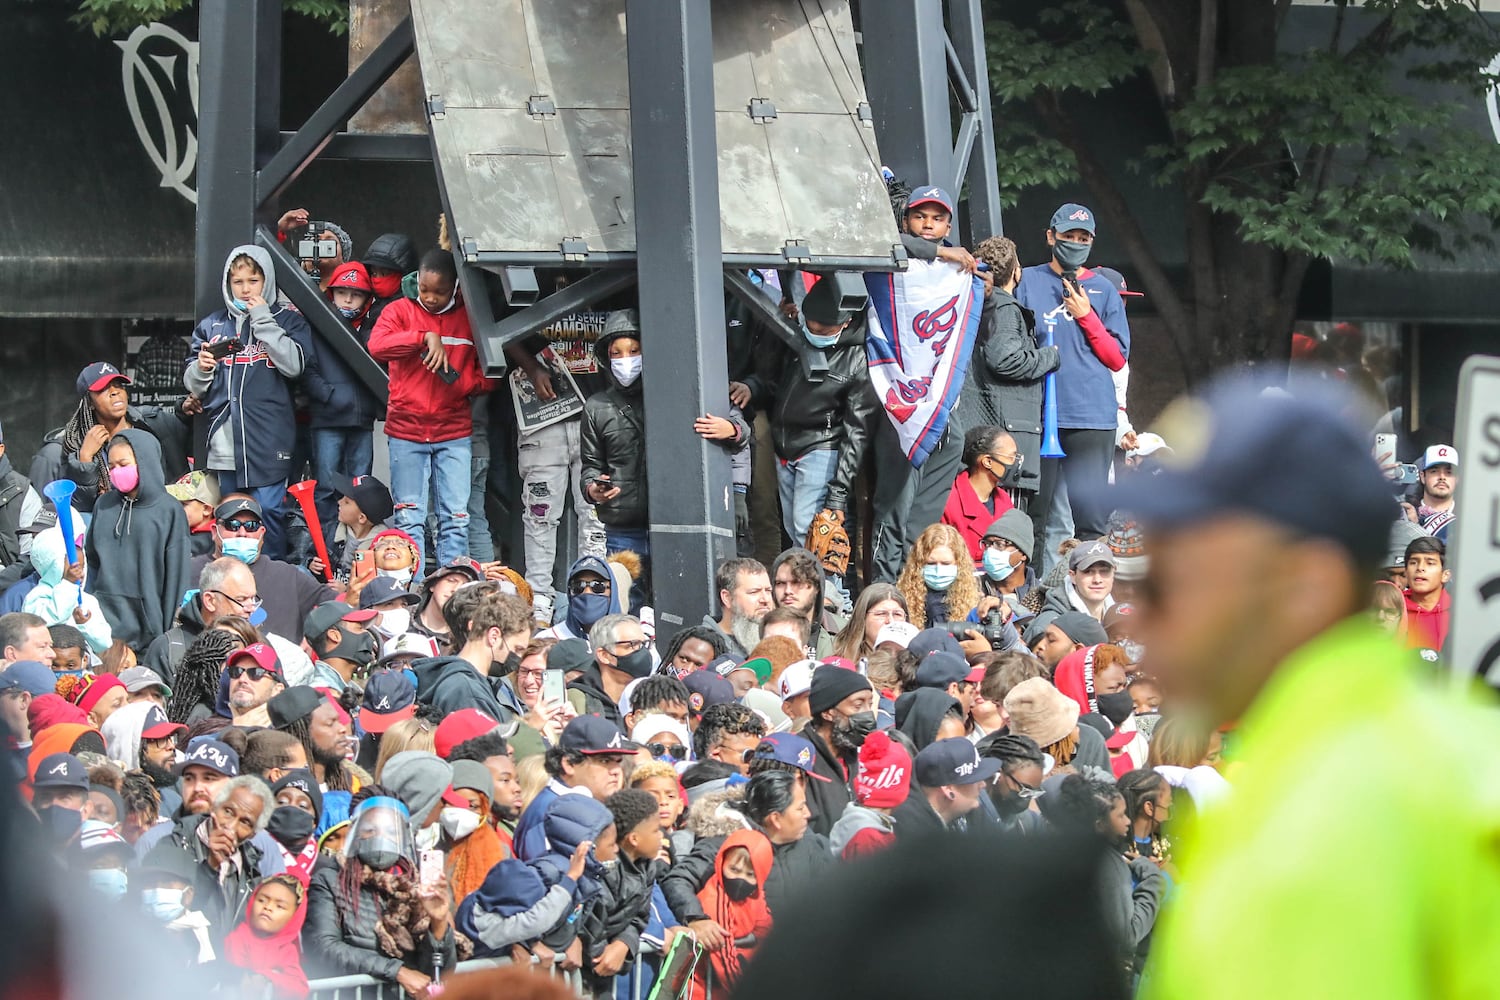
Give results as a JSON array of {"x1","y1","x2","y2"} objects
[{"x1": 626, "y1": 0, "x2": 735, "y2": 643}]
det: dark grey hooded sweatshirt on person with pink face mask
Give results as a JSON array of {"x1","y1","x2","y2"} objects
[{"x1": 84, "y1": 429, "x2": 192, "y2": 652}]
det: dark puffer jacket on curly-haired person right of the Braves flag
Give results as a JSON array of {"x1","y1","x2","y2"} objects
[{"x1": 957, "y1": 288, "x2": 1058, "y2": 490}]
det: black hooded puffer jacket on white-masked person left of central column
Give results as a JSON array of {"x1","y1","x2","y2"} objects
[{"x1": 579, "y1": 331, "x2": 650, "y2": 528}]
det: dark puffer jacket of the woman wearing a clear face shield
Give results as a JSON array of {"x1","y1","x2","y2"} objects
[{"x1": 302, "y1": 868, "x2": 459, "y2": 982}]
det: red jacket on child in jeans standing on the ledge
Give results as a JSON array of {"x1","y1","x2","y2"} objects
[{"x1": 369, "y1": 298, "x2": 491, "y2": 444}]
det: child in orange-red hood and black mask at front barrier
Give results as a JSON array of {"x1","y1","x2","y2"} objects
[{"x1": 689, "y1": 831, "x2": 773, "y2": 997}]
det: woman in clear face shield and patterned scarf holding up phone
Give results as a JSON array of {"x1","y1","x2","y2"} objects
[{"x1": 303, "y1": 796, "x2": 470, "y2": 997}]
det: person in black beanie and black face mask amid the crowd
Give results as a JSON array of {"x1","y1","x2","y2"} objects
[{"x1": 801, "y1": 664, "x2": 875, "y2": 837}]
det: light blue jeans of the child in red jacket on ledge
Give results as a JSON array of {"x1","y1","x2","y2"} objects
[{"x1": 387, "y1": 438, "x2": 471, "y2": 565}]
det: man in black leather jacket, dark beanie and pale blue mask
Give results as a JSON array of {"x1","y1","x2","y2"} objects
[{"x1": 735, "y1": 280, "x2": 876, "y2": 548}]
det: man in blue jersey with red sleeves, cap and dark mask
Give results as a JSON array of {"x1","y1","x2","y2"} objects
[{"x1": 1016, "y1": 202, "x2": 1130, "y2": 541}]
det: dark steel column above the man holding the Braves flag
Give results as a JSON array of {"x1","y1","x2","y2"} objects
[{"x1": 860, "y1": 0, "x2": 959, "y2": 198}]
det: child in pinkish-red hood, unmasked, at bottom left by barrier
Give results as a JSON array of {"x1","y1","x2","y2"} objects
[{"x1": 224, "y1": 874, "x2": 308, "y2": 1000}]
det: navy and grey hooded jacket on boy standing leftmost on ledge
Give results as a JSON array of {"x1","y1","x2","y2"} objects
[{"x1": 183, "y1": 244, "x2": 312, "y2": 487}]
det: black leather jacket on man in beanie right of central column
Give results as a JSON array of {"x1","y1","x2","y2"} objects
[{"x1": 746, "y1": 315, "x2": 881, "y2": 510}]
